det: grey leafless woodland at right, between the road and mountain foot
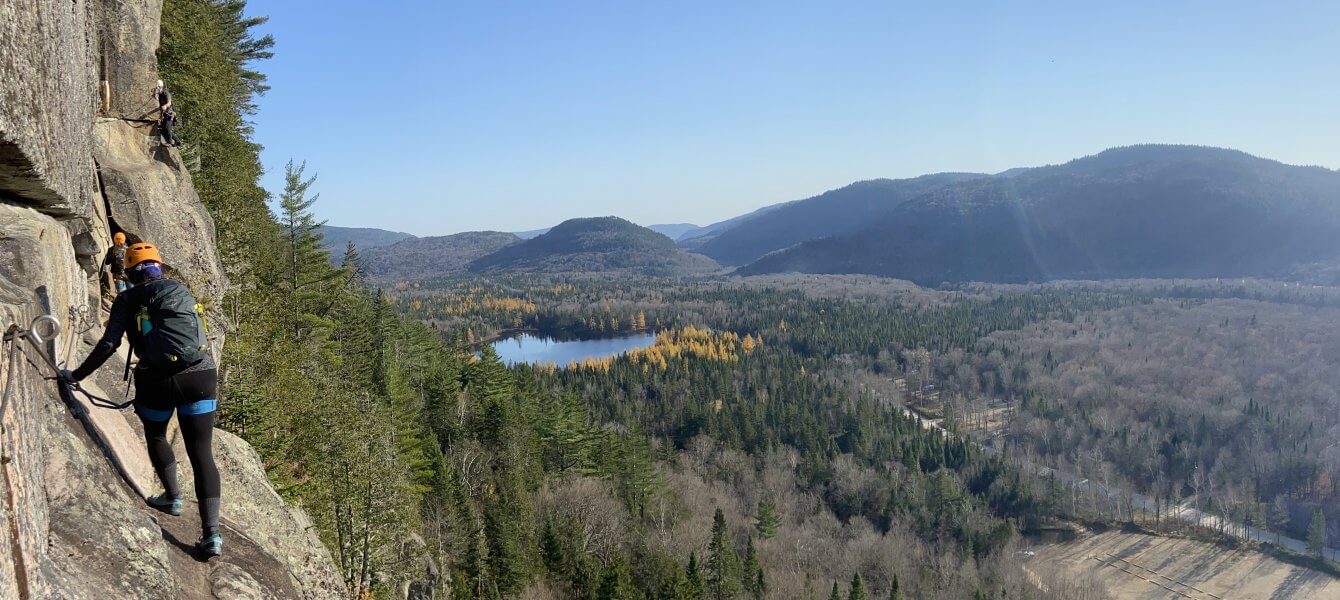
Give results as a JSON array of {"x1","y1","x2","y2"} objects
[{"x1": 964, "y1": 291, "x2": 1340, "y2": 544}]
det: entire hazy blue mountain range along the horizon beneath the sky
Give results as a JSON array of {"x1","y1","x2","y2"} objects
[{"x1": 323, "y1": 145, "x2": 1340, "y2": 285}]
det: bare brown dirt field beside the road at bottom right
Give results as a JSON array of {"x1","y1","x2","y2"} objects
[{"x1": 1029, "y1": 532, "x2": 1340, "y2": 600}]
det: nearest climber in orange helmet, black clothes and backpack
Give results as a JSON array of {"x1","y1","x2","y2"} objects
[{"x1": 62, "y1": 242, "x2": 224, "y2": 557}]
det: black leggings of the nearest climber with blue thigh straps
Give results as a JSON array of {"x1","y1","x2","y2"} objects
[{"x1": 135, "y1": 368, "x2": 221, "y2": 536}]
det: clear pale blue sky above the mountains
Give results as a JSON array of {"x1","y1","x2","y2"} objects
[{"x1": 249, "y1": 0, "x2": 1340, "y2": 234}]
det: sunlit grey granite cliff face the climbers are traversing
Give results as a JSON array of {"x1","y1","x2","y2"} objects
[{"x1": 0, "y1": 0, "x2": 347, "y2": 599}]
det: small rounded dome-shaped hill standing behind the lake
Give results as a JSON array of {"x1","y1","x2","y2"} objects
[{"x1": 469, "y1": 217, "x2": 718, "y2": 276}]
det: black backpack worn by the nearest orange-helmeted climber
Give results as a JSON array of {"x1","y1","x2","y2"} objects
[{"x1": 123, "y1": 279, "x2": 209, "y2": 370}]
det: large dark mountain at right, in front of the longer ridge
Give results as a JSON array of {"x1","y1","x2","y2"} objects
[{"x1": 745, "y1": 146, "x2": 1340, "y2": 285}]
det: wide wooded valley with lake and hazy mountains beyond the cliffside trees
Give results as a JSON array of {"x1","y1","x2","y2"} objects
[{"x1": 301, "y1": 146, "x2": 1340, "y2": 599}]
